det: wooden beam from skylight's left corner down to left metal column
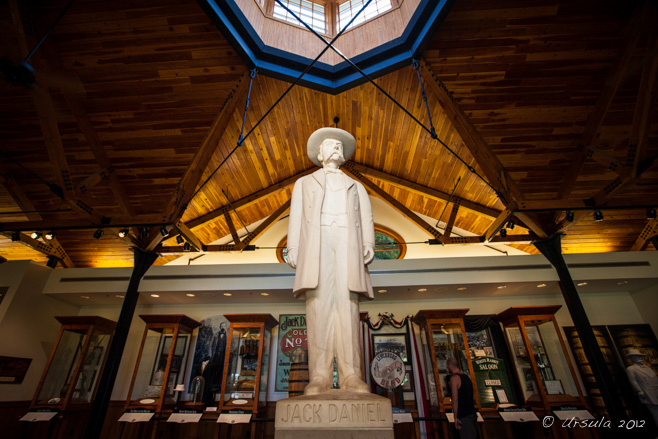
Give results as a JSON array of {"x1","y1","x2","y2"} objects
[{"x1": 163, "y1": 70, "x2": 254, "y2": 223}]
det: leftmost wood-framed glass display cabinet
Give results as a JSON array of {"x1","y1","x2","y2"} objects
[{"x1": 30, "y1": 316, "x2": 116, "y2": 411}]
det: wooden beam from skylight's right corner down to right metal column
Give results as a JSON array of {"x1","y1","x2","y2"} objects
[{"x1": 420, "y1": 60, "x2": 525, "y2": 205}]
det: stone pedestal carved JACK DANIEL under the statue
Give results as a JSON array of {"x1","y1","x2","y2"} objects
[{"x1": 274, "y1": 390, "x2": 393, "y2": 439}]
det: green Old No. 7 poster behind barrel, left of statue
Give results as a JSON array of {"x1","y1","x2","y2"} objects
[{"x1": 274, "y1": 314, "x2": 308, "y2": 392}]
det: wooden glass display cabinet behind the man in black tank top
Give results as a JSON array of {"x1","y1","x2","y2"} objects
[{"x1": 413, "y1": 308, "x2": 480, "y2": 416}]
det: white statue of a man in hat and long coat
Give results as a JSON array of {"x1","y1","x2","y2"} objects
[{"x1": 288, "y1": 128, "x2": 375, "y2": 395}]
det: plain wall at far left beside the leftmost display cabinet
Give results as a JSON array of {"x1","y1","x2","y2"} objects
[{"x1": 0, "y1": 261, "x2": 79, "y2": 401}]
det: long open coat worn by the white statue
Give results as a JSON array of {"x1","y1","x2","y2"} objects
[{"x1": 288, "y1": 169, "x2": 375, "y2": 299}]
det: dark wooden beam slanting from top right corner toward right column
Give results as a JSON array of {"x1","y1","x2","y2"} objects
[{"x1": 558, "y1": 2, "x2": 648, "y2": 199}]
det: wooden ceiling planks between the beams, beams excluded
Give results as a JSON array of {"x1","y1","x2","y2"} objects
[{"x1": 0, "y1": 0, "x2": 658, "y2": 267}]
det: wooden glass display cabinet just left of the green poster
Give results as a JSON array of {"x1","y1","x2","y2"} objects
[{"x1": 219, "y1": 314, "x2": 279, "y2": 413}]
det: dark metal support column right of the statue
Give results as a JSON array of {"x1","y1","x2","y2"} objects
[{"x1": 534, "y1": 235, "x2": 626, "y2": 422}]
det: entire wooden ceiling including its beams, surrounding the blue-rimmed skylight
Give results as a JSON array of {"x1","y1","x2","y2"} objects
[{"x1": 0, "y1": 0, "x2": 658, "y2": 267}]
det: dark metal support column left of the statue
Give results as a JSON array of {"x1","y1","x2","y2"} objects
[{"x1": 84, "y1": 249, "x2": 158, "y2": 439}]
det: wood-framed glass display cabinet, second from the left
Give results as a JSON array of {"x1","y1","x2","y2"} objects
[{"x1": 126, "y1": 314, "x2": 200, "y2": 412}]
